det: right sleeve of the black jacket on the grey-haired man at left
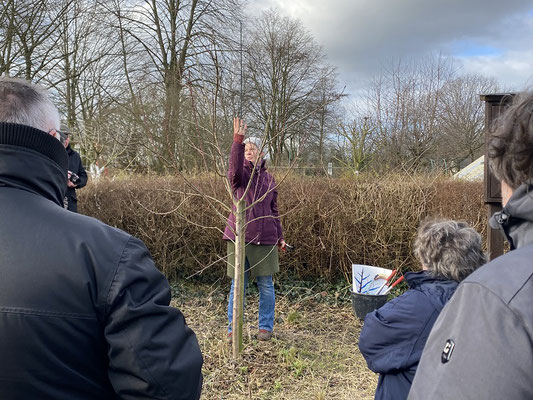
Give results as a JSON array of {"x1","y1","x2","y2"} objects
[{"x1": 104, "y1": 238, "x2": 203, "y2": 400}]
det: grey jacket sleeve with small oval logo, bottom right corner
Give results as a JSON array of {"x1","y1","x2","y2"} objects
[{"x1": 409, "y1": 282, "x2": 533, "y2": 400}]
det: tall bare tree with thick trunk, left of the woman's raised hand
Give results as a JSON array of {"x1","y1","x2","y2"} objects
[{"x1": 105, "y1": 0, "x2": 240, "y2": 170}]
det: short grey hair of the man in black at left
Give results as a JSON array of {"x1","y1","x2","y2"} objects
[{"x1": 0, "y1": 77, "x2": 60, "y2": 132}]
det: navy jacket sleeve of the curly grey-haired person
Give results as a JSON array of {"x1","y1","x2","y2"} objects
[{"x1": 359, "y1": 290, "x2": 436, "y2": 374}]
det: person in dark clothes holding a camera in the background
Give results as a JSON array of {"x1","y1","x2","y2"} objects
[{"x1": 59, "y1": 126, "x2": 88, "y2": 213}]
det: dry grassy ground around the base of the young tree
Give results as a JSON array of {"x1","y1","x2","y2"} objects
[{"x1": 173, "y1": 281, "x2": 377, "y2": 400}]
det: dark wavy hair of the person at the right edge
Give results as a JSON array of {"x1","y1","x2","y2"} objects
[{"x1": 487, "y1": 92, "x2": 533, "y2": 189}]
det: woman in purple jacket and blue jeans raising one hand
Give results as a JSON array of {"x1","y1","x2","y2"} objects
[{"x1": 223, "y1": 118, "x2": 286, "y2": 340}]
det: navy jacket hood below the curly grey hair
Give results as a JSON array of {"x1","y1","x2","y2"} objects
[{"x1": 404, "y1": 271, "x2": 459, "y2": 312}]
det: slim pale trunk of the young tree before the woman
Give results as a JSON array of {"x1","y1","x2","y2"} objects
[{"x1": 231, "y1": 199, "x2": 246, "y2": 359}]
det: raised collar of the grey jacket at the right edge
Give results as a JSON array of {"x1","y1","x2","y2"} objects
[{"x1": 490, "y1": 184, "x2": 533, "y2": 249}]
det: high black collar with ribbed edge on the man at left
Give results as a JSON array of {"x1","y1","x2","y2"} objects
[{"x1": 0, "y1": 122, "x2": 68, "y2": 205}]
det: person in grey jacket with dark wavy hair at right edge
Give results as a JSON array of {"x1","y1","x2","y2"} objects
[{"x1": 409, "y1": 92, "x2": 533, "y2": 400}]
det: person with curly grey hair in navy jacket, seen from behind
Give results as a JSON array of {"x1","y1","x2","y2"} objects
[{"x1": 359, "y1": 220, "x2": 486, "y2": 400}]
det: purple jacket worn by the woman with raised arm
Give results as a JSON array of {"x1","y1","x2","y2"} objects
[{"x1": 223, "y1": 141, "x2": 283, "y2": 245}]
